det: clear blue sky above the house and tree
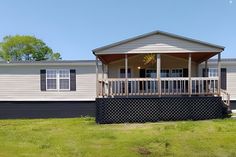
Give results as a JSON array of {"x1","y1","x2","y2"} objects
[{"x1": 0, "y1": 0, "x2": 236, "y2": 60}]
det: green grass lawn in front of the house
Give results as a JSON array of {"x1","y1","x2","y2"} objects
[{"x1": 0, "y1": 118, "x2": 236, "y2": 157}]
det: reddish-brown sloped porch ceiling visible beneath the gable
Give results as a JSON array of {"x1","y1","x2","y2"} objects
[{"x1": 98, "y1": 52, "x2": 216, "y2": 64}]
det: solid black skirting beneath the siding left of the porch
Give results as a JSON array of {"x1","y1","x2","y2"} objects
[{"x1": 0, "y1": 101, "x2": 96, "y2": 119}]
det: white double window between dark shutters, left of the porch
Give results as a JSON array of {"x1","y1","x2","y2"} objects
[{"x1": 46, "y1": 69, "x2": 70, "y2": 90}]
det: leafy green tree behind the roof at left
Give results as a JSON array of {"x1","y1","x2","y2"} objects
[{"x1": 0, "y1": 35, "x2": 61, "y2": 61}]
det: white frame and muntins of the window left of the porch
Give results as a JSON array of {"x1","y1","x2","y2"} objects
[{"x1": 46, "y1": 69, "x2": 70, "y2": 92}]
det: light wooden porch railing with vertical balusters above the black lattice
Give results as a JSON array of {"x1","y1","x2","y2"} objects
[{"x1": 98, "y1": 77, "x2": 218, "y2": 97}]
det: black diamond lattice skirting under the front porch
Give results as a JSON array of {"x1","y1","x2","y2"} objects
[{"x1": 96, "y1": 96, "x2": 227, "y2": 124}]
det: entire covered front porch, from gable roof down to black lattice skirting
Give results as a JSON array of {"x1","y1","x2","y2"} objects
[{"x1": 93, "y1": 31, "x2": 230, "y2": 123}]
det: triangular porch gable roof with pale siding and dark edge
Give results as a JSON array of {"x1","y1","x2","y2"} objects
[{"x1": 92, "y1": 30, "x2": 225, "y2": 55}]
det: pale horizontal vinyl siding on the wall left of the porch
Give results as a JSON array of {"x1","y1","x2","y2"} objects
[{"x1": 0, "y1": 65, "x2": 101, "y2": 101}]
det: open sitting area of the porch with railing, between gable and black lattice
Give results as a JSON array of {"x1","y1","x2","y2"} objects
[{"x1": 97, "y1": 53, "x2": 222, "y2": 97}]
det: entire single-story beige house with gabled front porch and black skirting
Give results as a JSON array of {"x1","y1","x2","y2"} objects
[{"x1": 0, "y1": 31, "x2": 236, "y2": 123}]
